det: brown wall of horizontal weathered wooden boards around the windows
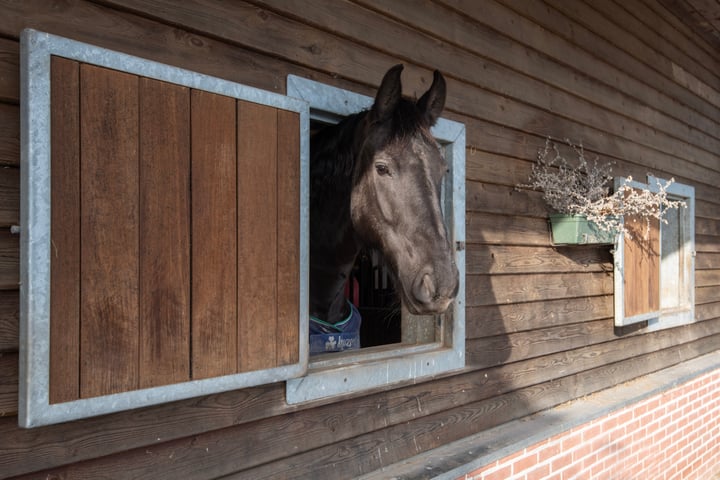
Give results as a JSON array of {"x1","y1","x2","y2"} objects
[{"x1": 0, "y1": 0, "x2": 720, "y2": 479}]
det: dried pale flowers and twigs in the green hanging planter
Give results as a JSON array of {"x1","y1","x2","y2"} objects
[{"x1": 518, "y1": 137, "x2": 685, "y2": 237}]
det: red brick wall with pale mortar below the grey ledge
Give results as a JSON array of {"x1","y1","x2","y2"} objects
[{"x1": 461, "y1": 371, "x2": 720, "y2": 480}]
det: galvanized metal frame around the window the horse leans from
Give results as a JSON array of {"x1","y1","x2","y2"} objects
[{"x1": 286, "y1": 75, "x2": 465, "y2": 404}]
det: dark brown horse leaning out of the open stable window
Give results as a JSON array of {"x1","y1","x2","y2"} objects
[{"x1": 309, "y1": 65, "x2": 458, "y2": 348}]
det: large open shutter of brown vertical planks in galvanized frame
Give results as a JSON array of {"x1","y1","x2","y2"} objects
[{"x1": 20, "y1": 32, "x2": 307, "y2": 426}]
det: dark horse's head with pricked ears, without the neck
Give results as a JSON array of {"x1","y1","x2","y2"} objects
[{"x1": 350, "y1": 65, "x2": 458, "y2": 314}]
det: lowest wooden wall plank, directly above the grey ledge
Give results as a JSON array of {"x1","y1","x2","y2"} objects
[{"x1": 225, "y1": 336, "x2": 718, "y2": 480}]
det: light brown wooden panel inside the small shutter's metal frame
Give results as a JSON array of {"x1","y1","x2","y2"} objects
[{"x1": 623, "y1": 217, "x2": 660, "y2": 317}]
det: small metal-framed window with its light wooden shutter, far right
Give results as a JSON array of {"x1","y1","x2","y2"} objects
[{"x1": 615, "y1": 177, "x2": 695, "y2": 329}]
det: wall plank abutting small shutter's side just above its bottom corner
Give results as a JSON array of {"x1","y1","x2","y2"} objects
[{"x1": 465, "y1": 295, "x2": 613, "y2": 340}]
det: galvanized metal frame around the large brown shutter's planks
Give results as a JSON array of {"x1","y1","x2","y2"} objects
[{"x1": 18, "y1": 30, "x2": 309, "y2": 427}]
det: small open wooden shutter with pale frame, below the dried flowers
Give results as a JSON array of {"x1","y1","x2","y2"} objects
[{"x1": 615, "y1": 179, "x2": 661, "y2": 326}]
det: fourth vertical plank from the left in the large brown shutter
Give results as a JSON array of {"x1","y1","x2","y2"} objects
[{"x1": 191, "y1": 90, "x2": 237, "y2": 378}]
